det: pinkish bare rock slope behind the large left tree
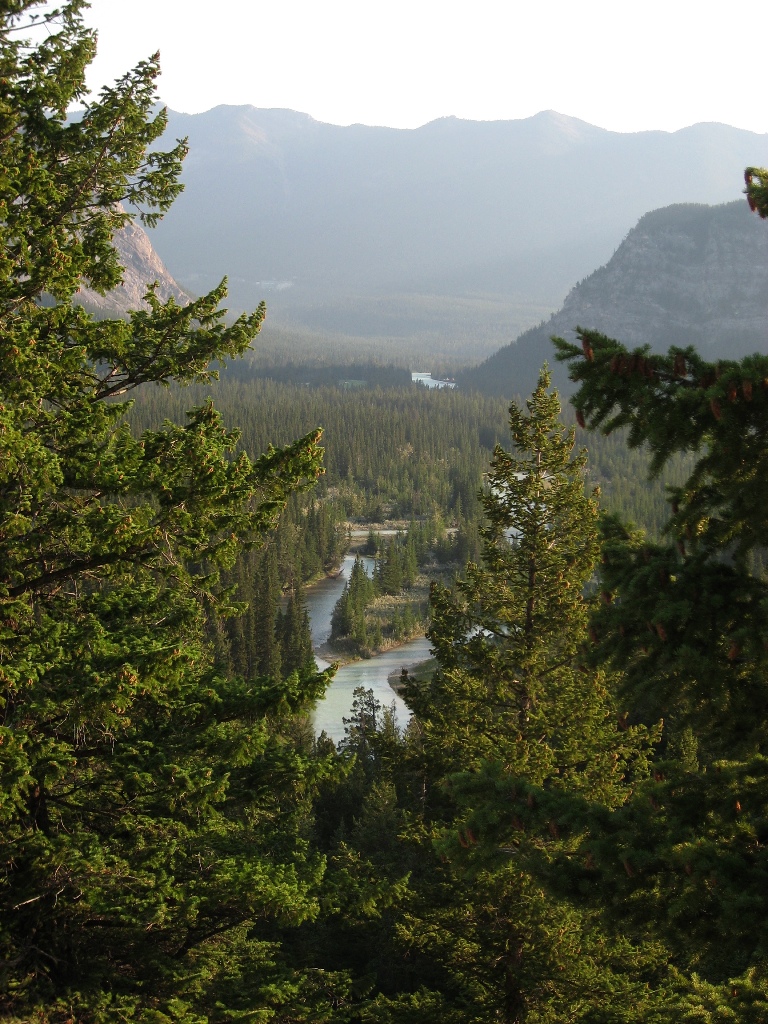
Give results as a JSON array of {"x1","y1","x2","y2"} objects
[{"x1": 77, "y1": 224, "x2": 191, "y2": 316}]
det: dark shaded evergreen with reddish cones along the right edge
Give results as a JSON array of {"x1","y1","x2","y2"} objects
[{"x1": 555, "y1": 174, "x2": 768, "y2": 1021}]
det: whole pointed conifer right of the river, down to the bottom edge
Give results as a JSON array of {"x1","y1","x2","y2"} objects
[{"x1": 391, "y1": 371, "x2": 657, "y2": 1024}]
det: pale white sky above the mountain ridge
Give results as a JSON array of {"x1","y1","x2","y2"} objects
[{"x1": 86, "y1": 0, "x2": 768, "y2": 132}]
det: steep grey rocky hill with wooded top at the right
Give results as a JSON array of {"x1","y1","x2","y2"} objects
[{"x1": 462, "y1": 201, "x2": 768, "y2": 395}]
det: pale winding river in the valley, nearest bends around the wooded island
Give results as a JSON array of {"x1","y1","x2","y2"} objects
[{"x1": 306, "y1": 555, "x2": 430, "y2": 742}]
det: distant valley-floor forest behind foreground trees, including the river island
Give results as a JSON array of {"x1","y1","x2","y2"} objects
[{"x1": 130, "y1": 378, "x2": 687, "y2": 669}]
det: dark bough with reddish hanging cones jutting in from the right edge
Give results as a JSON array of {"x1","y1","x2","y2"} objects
[{"x1": 555, "y1": 331, "x2": 768, "y2": 560}]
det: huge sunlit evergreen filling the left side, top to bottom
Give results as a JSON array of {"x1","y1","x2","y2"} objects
[{"x1": 0, "y1": 6, "x2": 333, "y2": 1024}]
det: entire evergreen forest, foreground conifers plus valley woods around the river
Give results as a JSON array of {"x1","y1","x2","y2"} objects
[{"x1": 7, "y1": 0, "x2": 768, "y2": 1024}]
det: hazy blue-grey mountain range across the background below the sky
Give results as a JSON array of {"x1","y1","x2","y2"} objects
[{"x1": 140, "y1": 106, "x2": 768, "y2": 359}]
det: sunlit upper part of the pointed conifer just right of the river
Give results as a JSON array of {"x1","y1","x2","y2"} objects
[{"x1": 411, "y1": 372, "x2": 651, "y2": 782}]
